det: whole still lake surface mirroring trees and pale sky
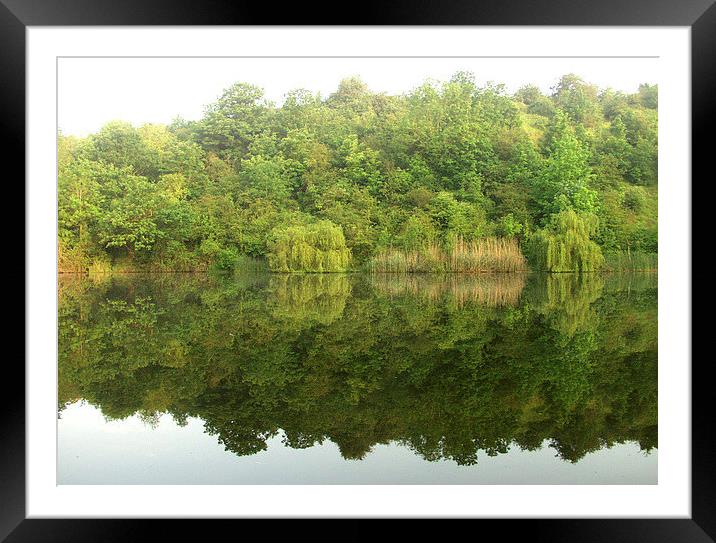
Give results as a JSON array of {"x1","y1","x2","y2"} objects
[{"x1": 58, "y1": 274, "x2": 657, "y2": 484}]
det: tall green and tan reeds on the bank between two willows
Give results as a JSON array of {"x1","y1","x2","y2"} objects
[{"x1": 368, "y1": 238, "x2": 528, "y2": 273}]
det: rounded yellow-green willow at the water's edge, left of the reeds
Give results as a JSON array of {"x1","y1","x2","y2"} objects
[{"x1": 268, "y1": 221, "x2": 351, "y2": 273}]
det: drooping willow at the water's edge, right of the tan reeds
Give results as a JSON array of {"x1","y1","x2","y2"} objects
[{"x1": 528, "y1": 209, "x2": 604, "y2": 272}]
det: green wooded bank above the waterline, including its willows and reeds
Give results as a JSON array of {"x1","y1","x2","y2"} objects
[{"x1": 58, "y1": 73, "x2": 657, "y2": 272}]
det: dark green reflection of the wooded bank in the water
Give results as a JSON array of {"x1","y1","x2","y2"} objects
[{"x1": 59, "y1": 275, "x2": 657, "y2": 464}]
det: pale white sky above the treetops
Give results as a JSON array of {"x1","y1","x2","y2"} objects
[{"x1": 58, "y1": 58, "x2": 658, "y2": 136}]
